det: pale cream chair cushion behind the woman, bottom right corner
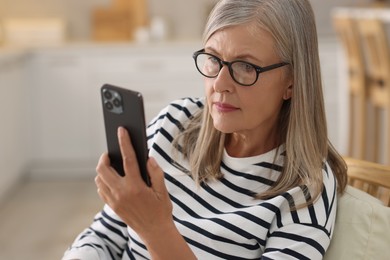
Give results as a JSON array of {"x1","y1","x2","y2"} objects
[{"x1": 324, "y1": 185, "x2": 390, "y2": 260}]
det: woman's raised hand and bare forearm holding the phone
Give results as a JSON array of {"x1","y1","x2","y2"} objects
[{"x1": 95, "y1": 127, "x2": 196, "y2": 260}]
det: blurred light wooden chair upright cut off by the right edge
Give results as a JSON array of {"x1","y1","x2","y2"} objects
[{"x1": 357, "y1": 18, "x2": 390, "y2": 164}]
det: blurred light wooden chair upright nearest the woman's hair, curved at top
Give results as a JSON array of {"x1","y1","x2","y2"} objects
[{"x1": 333, "y1": 14, "x2": 367, "y2": 159}]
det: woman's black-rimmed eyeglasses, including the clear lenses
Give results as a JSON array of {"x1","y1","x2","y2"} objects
[{"x1": 192, "y1": 49, "x2": 288, "y2": 86}]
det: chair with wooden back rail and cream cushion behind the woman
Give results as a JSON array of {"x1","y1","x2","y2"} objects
[{"x1": 324, "y1": 158, "x2": 390, "y2": 260}]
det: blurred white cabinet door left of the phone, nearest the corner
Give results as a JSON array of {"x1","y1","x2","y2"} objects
[{"x1": 28, "y1": 52, "x2": 89, "y2": 162}]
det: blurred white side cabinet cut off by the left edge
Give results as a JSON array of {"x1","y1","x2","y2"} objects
[{"x1": 0, "y1": 52, "x2": 30, "y2": 198}]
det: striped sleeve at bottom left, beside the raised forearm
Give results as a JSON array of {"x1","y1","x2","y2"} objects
[{"x1": 62, "y1": 205, "x2": 129, "y2": 260}]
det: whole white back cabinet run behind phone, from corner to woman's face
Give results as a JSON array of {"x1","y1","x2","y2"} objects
[{"x1": 28, "y1": 44, "x2": 203, "y2": 177}]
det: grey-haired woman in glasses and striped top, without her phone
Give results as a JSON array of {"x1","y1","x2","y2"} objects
[{"x1": 64, "y1": 0, "x2": 346, "y2": 259}]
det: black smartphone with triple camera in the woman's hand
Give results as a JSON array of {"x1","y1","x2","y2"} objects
[{"x1": 101, "y1": 84, "x2": 150, "y2": 186}]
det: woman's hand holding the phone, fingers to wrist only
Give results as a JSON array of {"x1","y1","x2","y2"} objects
[{"x1": 95, "y1": 127, "x2": 175, "y2": 240}]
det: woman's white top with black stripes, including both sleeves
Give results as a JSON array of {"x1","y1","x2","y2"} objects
[{"x1": 63, "y1": 99, "x2": 336, "y2": 260}]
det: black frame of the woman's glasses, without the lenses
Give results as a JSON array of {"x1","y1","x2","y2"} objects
[{"x1": 192, "y1": 49, "x2": 289, "y2": 87}]
